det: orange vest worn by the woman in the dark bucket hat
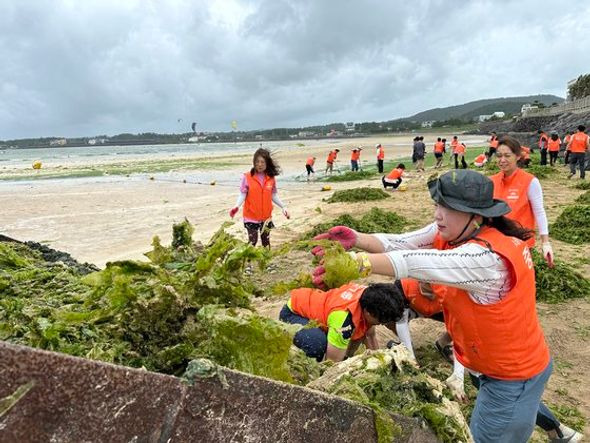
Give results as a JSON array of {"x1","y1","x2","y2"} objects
[{"x1": 434, "y1": 227, "x2": 550, "y2": 380}]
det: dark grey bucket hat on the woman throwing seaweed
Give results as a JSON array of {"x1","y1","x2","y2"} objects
[{"x1": 428, "y1": 169, "x2": 510, "y2": 217}]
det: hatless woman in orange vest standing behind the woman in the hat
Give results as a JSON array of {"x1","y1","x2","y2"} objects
[{"x1": 490, "y1": 136, "x2": 554, "y2": 267}]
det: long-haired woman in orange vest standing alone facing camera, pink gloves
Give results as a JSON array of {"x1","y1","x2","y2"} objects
[{"x1": 229, "y1": 148, "x2": 290, "y2": 248}]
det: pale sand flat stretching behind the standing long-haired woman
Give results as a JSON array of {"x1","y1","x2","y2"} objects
[{"x1": 0, "y1": 134, "x2": 483, "y2": 267}]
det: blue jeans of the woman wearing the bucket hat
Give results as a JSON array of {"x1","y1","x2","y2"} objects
[{"x1": 469, "y1": 361, "x2": 559, "y2": 443}]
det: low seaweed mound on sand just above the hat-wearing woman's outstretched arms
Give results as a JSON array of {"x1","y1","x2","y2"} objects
[{"x1": 304, "y1": 208, "x2": 414, "y2": 239}]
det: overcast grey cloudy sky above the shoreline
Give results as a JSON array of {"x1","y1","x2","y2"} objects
[{"x1": 0, "y1": 0, "x2": 590, "y2": 140}]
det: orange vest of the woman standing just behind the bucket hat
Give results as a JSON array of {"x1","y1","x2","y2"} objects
[{"x1": 490, "y1": 168, "x2": 535, "y2": 247}]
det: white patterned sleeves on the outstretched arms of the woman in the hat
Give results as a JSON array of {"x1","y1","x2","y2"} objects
[{"x1": 374, "y1": 223, "x2": 512, "y2": 305}]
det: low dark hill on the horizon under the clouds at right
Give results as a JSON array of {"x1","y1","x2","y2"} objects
[{"x1": 404, "y1": 95, "x2": 564, "y2": 122}]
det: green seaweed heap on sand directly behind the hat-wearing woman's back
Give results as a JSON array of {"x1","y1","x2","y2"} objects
[{"x1": 531, "y1": 249, "x2": 590, "y2": 303}]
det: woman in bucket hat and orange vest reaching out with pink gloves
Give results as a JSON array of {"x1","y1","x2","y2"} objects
[{"x1": 313, "y1": 170, "x2": 552, "y2": 442}]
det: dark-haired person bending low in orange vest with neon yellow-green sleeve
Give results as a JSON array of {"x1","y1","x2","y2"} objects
[{"x1": 279, "y1": 283, "x2": 405, "y2": 361}]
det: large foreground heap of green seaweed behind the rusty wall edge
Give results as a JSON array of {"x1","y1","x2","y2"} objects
[{"x1": 0, "y1": 220, "x2": 320, "y2": 381}]
